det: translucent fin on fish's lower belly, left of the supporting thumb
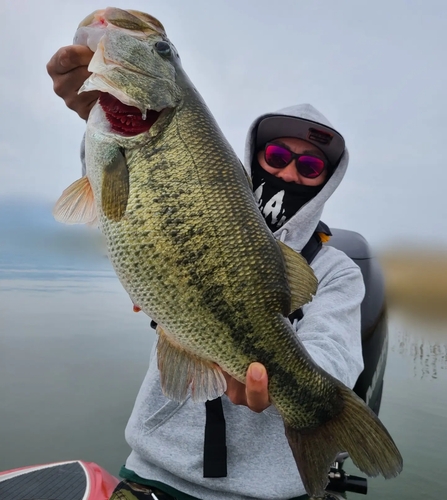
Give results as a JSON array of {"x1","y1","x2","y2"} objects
[{"x1": 157, "y1": 325, "x2": 227, "y2": 402}]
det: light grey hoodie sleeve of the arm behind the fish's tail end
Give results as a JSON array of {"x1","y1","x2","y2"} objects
[{"x1": 294, "y1": 254, "x2": 365, "y2": 388}]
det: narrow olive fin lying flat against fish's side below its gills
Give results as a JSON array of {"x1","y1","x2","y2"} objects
[{"x1": 101, "y1": 146, "x2": 129, "y2": 222}]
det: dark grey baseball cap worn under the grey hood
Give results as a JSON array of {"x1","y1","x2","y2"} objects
[{"x1": 256, "y1": 115, "x2": 345, "y2": 167}]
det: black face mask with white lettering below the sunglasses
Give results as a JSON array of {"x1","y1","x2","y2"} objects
[{"x1": 252, "y1": 156, "x2": 325, "y2": 232}]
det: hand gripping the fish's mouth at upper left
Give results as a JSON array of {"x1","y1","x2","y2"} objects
[{"x1": 47, "y1": 45, "x2": 99, "y2": 120}]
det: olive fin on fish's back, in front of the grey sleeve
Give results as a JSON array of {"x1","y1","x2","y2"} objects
[{"x1": 278, "y1": 241, "x2": 318, "y2": 312}]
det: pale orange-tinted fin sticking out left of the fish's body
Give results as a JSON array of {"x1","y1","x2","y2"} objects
[{"x1": 53, "y1": 176, "x2": 96, "y2": 224}]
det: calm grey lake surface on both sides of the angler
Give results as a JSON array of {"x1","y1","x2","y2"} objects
[{"x1": 0, "y1": 266, "x2": 447, "y2": 500}]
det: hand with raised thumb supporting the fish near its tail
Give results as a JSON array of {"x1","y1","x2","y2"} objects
[{"x1": 223, "y1": 363, "x2": 270, "y2": 413}]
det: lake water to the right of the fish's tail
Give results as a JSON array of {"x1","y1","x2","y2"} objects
[{"x1": 362, "y1": 311, "x2": 447, "y2": 500}]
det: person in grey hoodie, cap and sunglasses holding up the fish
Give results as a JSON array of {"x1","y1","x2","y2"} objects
[{"x1": 47, "y1": 46, "x2": 364, "y2": 500}]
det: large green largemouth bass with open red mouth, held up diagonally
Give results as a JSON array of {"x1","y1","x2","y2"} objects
[{"x1": 53, "y1": 8, "x2": 402, "y2": 497}]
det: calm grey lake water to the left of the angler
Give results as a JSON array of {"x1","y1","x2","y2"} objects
[{"x1": 0, "y1": 271, "x2": 154, "y2": 474}]
